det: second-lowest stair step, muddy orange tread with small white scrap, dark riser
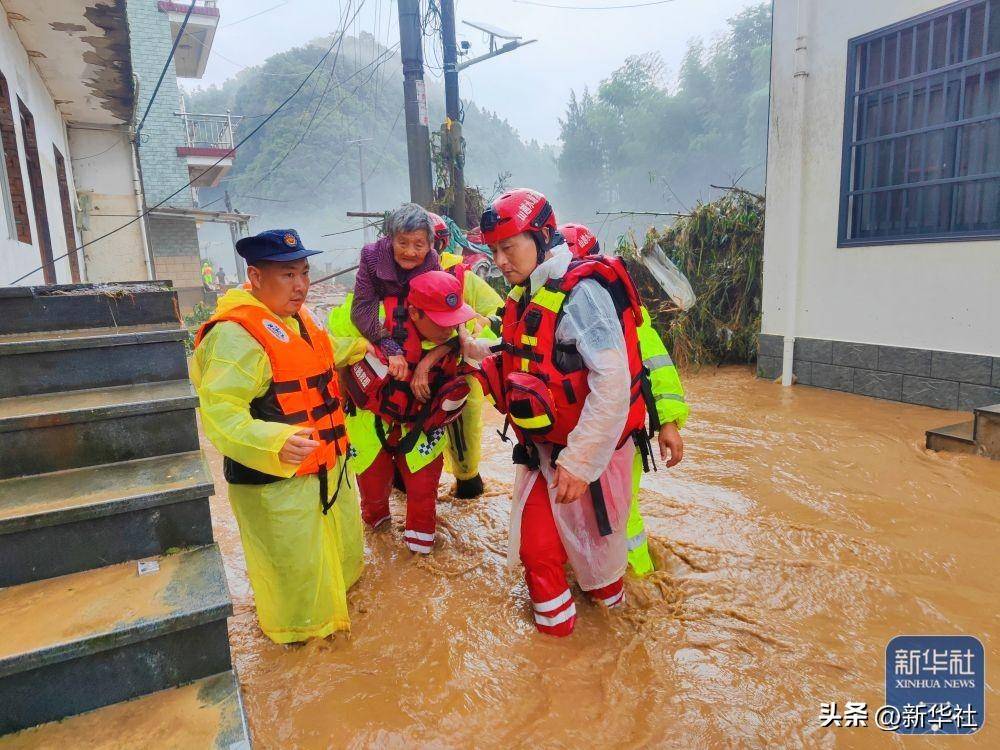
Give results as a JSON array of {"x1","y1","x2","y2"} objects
[{"x1": 0, "y1": 545, "x2": 232, "y2": 734}]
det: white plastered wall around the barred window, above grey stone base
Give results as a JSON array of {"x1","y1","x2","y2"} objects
[{"x1": 762, "y1": 0, "x2": 1000, "y2": 356}]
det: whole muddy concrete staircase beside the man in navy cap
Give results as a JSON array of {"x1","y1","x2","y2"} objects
[{"x1": 0, "y1": 282, "x2": 249, "y2": 750}]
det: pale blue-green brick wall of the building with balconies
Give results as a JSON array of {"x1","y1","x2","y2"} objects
[{"x1": 127, "y1": 0, "x2": 197, "y2": 209}]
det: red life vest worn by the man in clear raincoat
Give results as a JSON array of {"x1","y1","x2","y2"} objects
[{"x1": 501, "y1": 256, "x2": 646, "y2": 447}]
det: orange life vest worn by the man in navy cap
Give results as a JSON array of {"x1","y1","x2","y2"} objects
[{"x1": 195, "y1": 305, "x2": 347, "y2": 512}]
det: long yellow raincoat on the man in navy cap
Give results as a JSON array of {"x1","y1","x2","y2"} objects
[{"x1": 191, "y1": 289, "x2": 364, "y2": 643}]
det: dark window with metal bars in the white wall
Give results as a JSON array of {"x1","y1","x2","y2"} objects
[{"x1": 838, "y1": 0, "x2": 1000, "y2": 246}]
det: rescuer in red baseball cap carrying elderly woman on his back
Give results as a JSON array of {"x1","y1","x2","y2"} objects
[{"x1": 329, "y1": 271, "x2": 476, "y2": 554}]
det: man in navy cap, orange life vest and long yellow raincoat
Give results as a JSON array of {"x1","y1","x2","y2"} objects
[{"x1": 191, "y1": 230, "x2": 364, "y2": 643}]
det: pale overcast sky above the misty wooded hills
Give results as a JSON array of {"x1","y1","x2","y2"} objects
[{"x1": 183, "y1": 0, "x2": 753, "y2": 143}]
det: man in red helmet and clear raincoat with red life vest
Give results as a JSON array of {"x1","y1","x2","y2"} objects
[{"x1": 463, "y1": 189, "x2": 648, "y2": 636}]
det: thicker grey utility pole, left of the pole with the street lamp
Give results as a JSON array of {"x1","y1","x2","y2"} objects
[{"x1": 399, "y1": 0, "x2": 434, "y2": 208}]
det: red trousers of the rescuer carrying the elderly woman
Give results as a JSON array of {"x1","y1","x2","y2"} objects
[{"x1": 358, "y1": 450, "x2": 444, "y2": 555}]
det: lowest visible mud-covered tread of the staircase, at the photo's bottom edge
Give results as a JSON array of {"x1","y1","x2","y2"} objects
[{"x1": 0, "y1": 672, "x2": 250, "y2": 750}]
